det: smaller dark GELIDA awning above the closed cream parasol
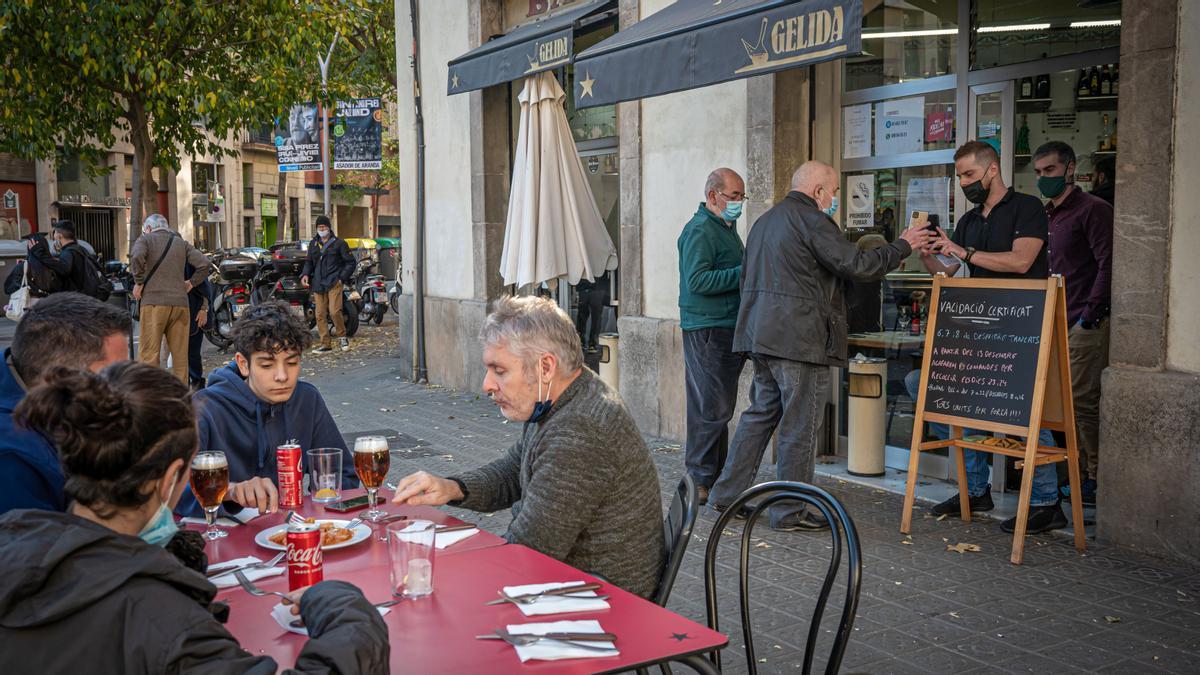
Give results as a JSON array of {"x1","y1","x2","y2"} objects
[{"x1": 446, "y1": 0, "x2": 617, "y2": 94}]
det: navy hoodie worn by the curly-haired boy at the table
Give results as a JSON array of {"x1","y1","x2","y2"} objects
[{"x1": 175, "y1": 362, "x2": 359, "y2": 516}]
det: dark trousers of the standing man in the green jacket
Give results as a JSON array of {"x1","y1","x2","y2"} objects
[{"x1": 683, "y1": 328, "x2": 745, "y2": 488}]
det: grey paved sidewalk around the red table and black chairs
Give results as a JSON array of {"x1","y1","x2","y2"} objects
[{"x1": 292, "y1": 345, "x2": 1200, "y2": 674}]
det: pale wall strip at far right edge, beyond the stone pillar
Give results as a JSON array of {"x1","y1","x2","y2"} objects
[{"x1": 1166, "y1": 2, "x2": 1200, "y2": 372}]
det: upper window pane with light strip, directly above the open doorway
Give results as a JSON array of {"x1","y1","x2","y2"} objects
[{"x1": 971, "y1": 0, "x2": 1121, "y2": 70}]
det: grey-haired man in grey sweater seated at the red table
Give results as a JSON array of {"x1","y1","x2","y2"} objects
[{"x1": 392, "y1": 298, "x2": 665, "y2": 597}]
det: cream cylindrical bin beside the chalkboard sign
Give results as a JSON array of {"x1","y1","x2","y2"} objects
[{"x1": 846, "y1": 354, "x2": 888, "y2": 477}]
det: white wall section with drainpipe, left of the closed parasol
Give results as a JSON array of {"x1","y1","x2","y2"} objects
[{"x1": 396, "y1": 0, "x2": 474, "y2": 299}]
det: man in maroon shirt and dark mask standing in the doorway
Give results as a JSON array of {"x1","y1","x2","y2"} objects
[{"x1": 1033, "y1": 141, "x2": 1112, "y2": 504}]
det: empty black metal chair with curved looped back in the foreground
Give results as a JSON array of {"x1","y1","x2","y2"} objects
[{"x1": 704, "y1": 480, "x2": 863, "y2": 675}]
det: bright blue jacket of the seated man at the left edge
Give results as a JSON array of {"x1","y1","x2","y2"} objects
[{"x1": 0, "y1": 350, "x2": 67, "y2": 513}]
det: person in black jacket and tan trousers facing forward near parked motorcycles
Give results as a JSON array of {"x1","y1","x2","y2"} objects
[{"x1": 300, "y1": 215, "x2": 355, "y2": 354}]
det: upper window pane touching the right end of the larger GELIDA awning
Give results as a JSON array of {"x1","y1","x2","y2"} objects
[{"x1": 844, "y1": 0, "x2": 959, "y2": 91}]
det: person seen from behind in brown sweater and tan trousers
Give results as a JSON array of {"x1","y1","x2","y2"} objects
[{"x1": 130, "y1": 214, "x2": 212, "y2": 384}]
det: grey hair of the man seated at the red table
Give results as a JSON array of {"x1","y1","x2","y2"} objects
[{"x1": 479, "y1": 297, "x2": 583, "y2": 380}]
